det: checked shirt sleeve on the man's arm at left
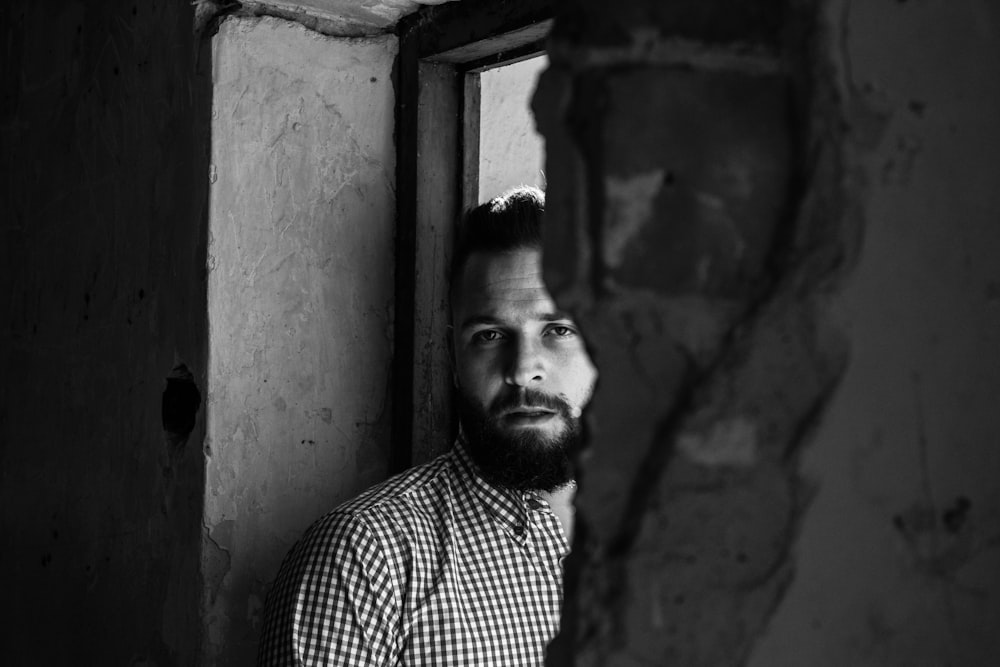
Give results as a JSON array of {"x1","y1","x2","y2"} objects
[{"x1": 257, "y1": 512, "x2": 400, "y2": 667}]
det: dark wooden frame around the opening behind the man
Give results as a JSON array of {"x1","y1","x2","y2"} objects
[{"x1": 389, "y1": 0, "x2": 553, "y2": 473}]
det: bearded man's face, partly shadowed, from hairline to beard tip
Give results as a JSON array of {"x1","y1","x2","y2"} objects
[{"x1": 452, "y1": 249, "x2": 597, "y2": 491}]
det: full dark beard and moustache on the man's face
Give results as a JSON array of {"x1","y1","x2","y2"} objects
[{"x1": 458, "y1": 389, "x2": 581, "y2": 491}]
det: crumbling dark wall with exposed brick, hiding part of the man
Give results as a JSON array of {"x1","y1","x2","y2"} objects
[{"x1": 535, "y1": 0, "x2": 1000, "y2": 666}]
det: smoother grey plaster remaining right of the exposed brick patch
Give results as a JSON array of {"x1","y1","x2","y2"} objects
[{"x1": 749, "y1": 1, "x2": 1000, "y2": 667}]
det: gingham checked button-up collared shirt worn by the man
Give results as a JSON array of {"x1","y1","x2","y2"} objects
[{"x1": 258, "y1": 443, "x2": 569, "y2": 667}]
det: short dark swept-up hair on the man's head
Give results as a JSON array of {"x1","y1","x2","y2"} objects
[{"x1": 451, "y1": 185, "x2": 545, "y2": 289}]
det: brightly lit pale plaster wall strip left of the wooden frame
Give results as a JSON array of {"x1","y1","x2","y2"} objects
[{"x1": 203, "y1": 18, "x2": 396, "y2": 665}]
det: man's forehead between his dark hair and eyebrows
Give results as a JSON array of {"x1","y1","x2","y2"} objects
[{"x1": 452, "y1": 248, "x2": 553, "y2": 322}]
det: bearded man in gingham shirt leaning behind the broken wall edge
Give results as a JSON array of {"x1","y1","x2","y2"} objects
[{"x1": 258, "y1": 188, "x2": 596, "y2": 667}]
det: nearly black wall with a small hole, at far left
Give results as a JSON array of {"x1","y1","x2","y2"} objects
[{"x1": 0, "y1": 2, "x2": 209, "y2": 665}]
